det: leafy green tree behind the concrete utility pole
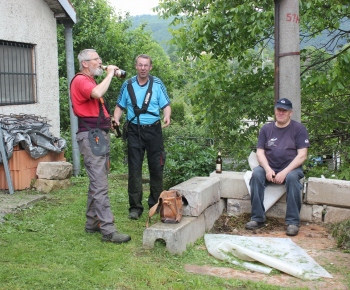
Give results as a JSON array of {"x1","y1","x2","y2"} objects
[{"x1": 155, "y1": 0, "x2": 350, "y2": 174}]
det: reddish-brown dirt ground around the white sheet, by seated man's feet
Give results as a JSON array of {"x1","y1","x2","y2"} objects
[{"x1": 186, "y1": 215, "x2": 350, "y2": 290}]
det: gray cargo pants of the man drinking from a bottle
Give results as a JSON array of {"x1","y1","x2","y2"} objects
[{"x1": 77, "y1": 132, "x2": 116, "y2": 235}]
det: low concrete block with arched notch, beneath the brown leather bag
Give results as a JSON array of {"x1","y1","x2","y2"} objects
[{"x1": 143, "y1": 214, "x2": 205, "y2": 254}]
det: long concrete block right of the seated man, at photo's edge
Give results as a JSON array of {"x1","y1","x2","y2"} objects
[{"x1": 306, "y1": 177, "x2": 350, "y2": 208}]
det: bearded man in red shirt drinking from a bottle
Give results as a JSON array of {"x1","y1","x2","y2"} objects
[{"x1": 70, "y1": 49, "x2": 131, "y2": 243}]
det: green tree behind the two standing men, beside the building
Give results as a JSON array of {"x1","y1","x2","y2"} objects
[{"x1": 58, "y1": 0, "x2": 176, "y2": 130}]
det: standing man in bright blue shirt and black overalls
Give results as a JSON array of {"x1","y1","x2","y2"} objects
[{"x1": 114, "y1": 54, "x2": 171, "y2": 220}]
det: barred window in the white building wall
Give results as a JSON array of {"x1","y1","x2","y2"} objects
[{"x1": 0, "y1": 40, "x2": 36, "y2": 106}]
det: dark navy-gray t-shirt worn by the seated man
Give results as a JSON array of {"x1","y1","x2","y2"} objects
[{"x1": 257, "y1": 120, "x2": 310, "y2": 173}]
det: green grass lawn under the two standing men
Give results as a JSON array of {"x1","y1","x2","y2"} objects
[{"x1": 0, "y1": 175, "x2": 318, "y2": 290}]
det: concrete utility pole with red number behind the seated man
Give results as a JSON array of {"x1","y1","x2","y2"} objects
[{"x1": 275, "y1": 0, "x2": 301, "y2": 122}]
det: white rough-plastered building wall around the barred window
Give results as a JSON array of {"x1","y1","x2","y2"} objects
[{"x1": 0, "y1": 0, "x2": 60, "y2": 137}]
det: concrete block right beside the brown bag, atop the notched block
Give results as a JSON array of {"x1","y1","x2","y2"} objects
[{"x1": 170, "y1": 177, "x2": 220, "y2": 216}]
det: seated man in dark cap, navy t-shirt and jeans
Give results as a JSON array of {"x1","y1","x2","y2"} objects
[{"x1": 246, "y1": 98, "x2": 310, "y2": 236}]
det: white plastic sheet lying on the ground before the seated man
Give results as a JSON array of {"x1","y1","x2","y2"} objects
[{"x1": 204, "y1": 234, "x2": 333, "y2": 280}]
